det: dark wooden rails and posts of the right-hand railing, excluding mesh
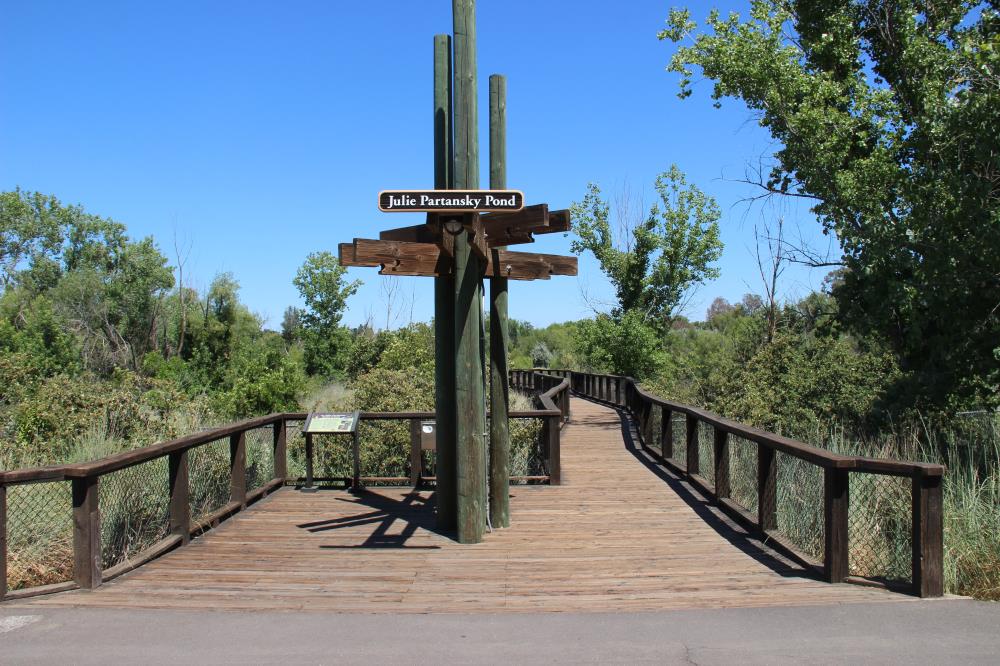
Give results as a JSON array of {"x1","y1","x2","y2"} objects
[{"x1": 544, "y1": 369, "x2": 946, "y2": 597}]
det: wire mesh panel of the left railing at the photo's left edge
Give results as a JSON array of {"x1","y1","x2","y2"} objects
[{"x1": 7, "y1": 481, "x2": 73, "y2": 590}]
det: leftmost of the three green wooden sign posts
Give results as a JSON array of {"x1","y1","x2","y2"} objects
[{"x1": 434, "y1": 35, "x2": 458, "y2": 530}]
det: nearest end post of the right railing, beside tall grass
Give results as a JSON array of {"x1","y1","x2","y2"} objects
[{"x1": 912, "y1": 476, "x2": 944, "y2": 597}]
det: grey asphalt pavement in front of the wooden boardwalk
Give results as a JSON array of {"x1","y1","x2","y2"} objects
[{"x1": 0, "y1": 599, "x2": 1000, "y2": 666}]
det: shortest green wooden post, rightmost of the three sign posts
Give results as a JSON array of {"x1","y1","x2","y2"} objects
[{"x1": 490, "y1": 74, "x2": 510, "y2": 527}]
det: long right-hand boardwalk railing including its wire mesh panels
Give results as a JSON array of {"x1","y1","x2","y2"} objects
[{"x1": 523, "y1": 369, "x2": 945, "y2": 597}]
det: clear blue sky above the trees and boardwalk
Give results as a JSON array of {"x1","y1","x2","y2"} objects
[{"x1": 0, "y1": 0, "x2": 836, "y2": 327}]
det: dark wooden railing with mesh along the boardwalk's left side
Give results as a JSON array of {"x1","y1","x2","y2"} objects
[{"x1": 0, "y1": 375, "x2": 569, "y2": 600}]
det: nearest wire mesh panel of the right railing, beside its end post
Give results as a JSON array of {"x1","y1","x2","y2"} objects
[{"x1": 848, "y1": 474, "x2": 912, "y2": 581}]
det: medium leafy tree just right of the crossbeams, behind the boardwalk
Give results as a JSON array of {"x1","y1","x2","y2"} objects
[{"x1": 571, "y1": 166, "x2": 722, "y2": 330}]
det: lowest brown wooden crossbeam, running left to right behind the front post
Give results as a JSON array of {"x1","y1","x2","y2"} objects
[{"x1": 339, "y1": 238, "x2": 577, "y2": 280}]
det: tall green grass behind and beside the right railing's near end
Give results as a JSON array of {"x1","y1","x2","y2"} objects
[{"x1": 731, "y1": 413, "x2": 1000, "y2": 600}]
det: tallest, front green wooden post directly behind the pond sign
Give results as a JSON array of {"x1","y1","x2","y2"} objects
[{"x1": 452, "y1": 0, "x2": 487, "y2": 543}]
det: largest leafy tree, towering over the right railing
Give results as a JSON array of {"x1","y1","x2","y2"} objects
[{"x1": 659, "y1": 0, "x2": 1000, "y2": 402}]
